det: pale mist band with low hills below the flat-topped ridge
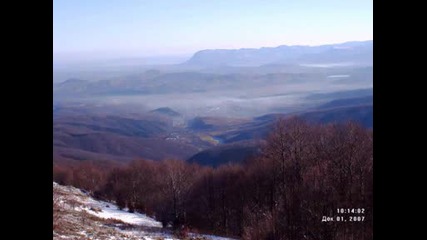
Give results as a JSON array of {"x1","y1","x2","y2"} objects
[{"x1": 54, "y1": 68, "x2": 372, "y2": 118}]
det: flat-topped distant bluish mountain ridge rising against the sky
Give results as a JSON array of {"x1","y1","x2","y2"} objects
[{"x1": 186, "y1": 40, "x2": 373, "y2": 66}]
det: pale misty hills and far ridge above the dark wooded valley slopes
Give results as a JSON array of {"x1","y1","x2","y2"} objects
[{"x1": 53, "y1": 41, "x2": 373, "y2": 117}]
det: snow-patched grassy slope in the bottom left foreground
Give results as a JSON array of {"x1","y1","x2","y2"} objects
[{"x1": 53, "y1": 182, "x2": 237, "y2": 240}]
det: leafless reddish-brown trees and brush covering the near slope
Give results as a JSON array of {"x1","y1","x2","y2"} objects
[{"x1": 54, "y1": 118, "x2": 373, "y2": 240}]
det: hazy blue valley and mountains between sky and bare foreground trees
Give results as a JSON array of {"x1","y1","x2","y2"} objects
[{"x1": 53, "y1": 41, "x2": 373, "y2": 166}]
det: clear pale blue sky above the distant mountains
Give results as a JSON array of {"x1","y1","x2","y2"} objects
[{"x1": 53, "y1": 0, "x2": 373, "y2": 61}]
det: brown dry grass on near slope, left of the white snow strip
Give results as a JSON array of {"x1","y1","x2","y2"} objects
[{"x1": 53, "y1": 184, "x2": 232, "y2": 240}]
